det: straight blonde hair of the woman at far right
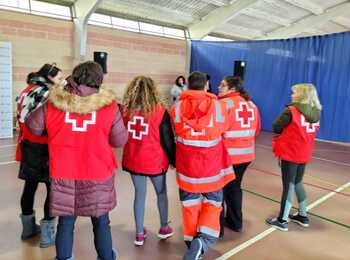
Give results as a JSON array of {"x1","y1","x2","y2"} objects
[{"x1": 292, "y1": 83, "x2": 322, "y2": 110}]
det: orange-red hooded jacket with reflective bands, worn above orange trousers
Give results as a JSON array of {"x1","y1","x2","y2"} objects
[{"x1": 171, "y1": 90, "x2": 235, "y2": 193}]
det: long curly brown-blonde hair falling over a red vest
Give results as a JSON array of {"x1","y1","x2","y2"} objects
[{"x1": 123, "y1": 76, "x2": 165, "y2": 116}]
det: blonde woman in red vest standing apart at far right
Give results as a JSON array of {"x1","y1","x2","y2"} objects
[{"x1": 266, "y1": 84, "x2": 322, "y2": 231}]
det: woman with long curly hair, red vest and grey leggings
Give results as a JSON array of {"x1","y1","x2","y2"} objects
[{"x1": 122, "y1": 76, "x2": 175, "y2": 246}]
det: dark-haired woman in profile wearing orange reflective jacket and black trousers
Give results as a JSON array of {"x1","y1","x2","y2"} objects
[{"x1": 219, "y1": 76, "x2": 260, "y2": 236}]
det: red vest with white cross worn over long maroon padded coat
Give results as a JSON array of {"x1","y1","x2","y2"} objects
[{"x1": 45, "y1": 102, "x2": 117, "y2": 180}]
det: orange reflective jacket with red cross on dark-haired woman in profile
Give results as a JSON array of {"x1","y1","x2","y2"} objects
[{"x1": 222, "y1": 92, "x2": 260, "y2": 165}]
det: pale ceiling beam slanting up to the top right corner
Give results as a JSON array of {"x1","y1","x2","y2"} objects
[{"x1": 257, "y1": 2, "x2": 350, "y2": 40}]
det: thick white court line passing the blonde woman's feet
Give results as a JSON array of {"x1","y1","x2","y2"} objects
[{"x1": 215, "y1": 181, "x2": 350, "y2": 260}]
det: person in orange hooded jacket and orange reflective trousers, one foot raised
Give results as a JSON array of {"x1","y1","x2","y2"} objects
[{"x1": 171, "y1": 72, "x2": 235, "y2": 260}]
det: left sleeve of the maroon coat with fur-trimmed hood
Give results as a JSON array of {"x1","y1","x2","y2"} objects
[{"x1": 25, "y1": 102, "x2": 47, "y2": 136}]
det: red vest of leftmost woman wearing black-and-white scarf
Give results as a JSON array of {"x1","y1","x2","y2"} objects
[{"x1": 16, "y1": 84, "x2": 47, "y2": 161}]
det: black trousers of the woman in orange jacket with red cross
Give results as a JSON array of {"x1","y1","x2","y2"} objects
[{"x1": 220, "y1": 162, "x2": 251, "y2": 231}]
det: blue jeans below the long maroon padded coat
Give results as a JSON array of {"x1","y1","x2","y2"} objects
[{"x1": 56, "y1": 213, "x2": 116, "y2": 260}]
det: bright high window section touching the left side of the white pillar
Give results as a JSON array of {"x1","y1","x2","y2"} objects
[{"x1": 30, "y1": 0, "x2": 71, "y2": 20}]
